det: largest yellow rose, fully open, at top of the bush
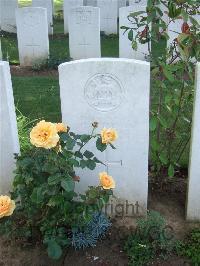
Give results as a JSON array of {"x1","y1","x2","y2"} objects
[{"x1": 30, "y1": 120, "x2": 60, "y2": 149}]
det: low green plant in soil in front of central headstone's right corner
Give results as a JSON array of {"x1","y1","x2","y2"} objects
[{"x1": 125, "y1": 211, "x2": 176, "y2": 266}]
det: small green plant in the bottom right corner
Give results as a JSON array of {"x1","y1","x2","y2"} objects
[{"x1": 177, "y1": 228, "x2": 200, "y2": 266}]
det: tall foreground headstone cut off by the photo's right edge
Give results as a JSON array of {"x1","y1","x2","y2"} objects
[{"x1": 187, "y1": 63, "x2": 200, "y2": 221}]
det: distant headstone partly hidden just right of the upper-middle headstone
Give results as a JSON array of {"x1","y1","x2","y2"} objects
[{"x1": 97, "y1": 0, "x2": 118, "y2": 34}]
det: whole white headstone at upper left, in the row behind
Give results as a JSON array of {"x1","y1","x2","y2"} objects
[{"x1": 16, "y1": 7, "x2": 49, "y2": 66}]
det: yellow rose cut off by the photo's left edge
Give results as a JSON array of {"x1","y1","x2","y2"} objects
[{"x1": 0, "y1": 196, "x2": 15, "y2": 218}]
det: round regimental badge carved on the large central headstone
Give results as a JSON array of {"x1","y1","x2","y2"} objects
[{"x1": 84, "y1": 74, "x2": 124, "y2": 112}]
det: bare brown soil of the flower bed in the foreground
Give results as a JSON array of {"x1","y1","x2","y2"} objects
[{"x1": 0, "y1": 178, "x2": 200, "y2": 266}]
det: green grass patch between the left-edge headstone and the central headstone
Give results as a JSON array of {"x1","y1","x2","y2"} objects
[{"x1": 12, "y1": 76, "x2": 61, "y2": 122}]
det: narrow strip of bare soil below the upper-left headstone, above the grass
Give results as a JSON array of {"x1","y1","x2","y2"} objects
[{"x1": 11, "y1": 65, "x2": 58, "y2": 77}]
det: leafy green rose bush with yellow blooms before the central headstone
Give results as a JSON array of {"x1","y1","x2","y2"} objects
[{"x1": 0, "y1": 120, "x2": 117, "y2": 259}]
